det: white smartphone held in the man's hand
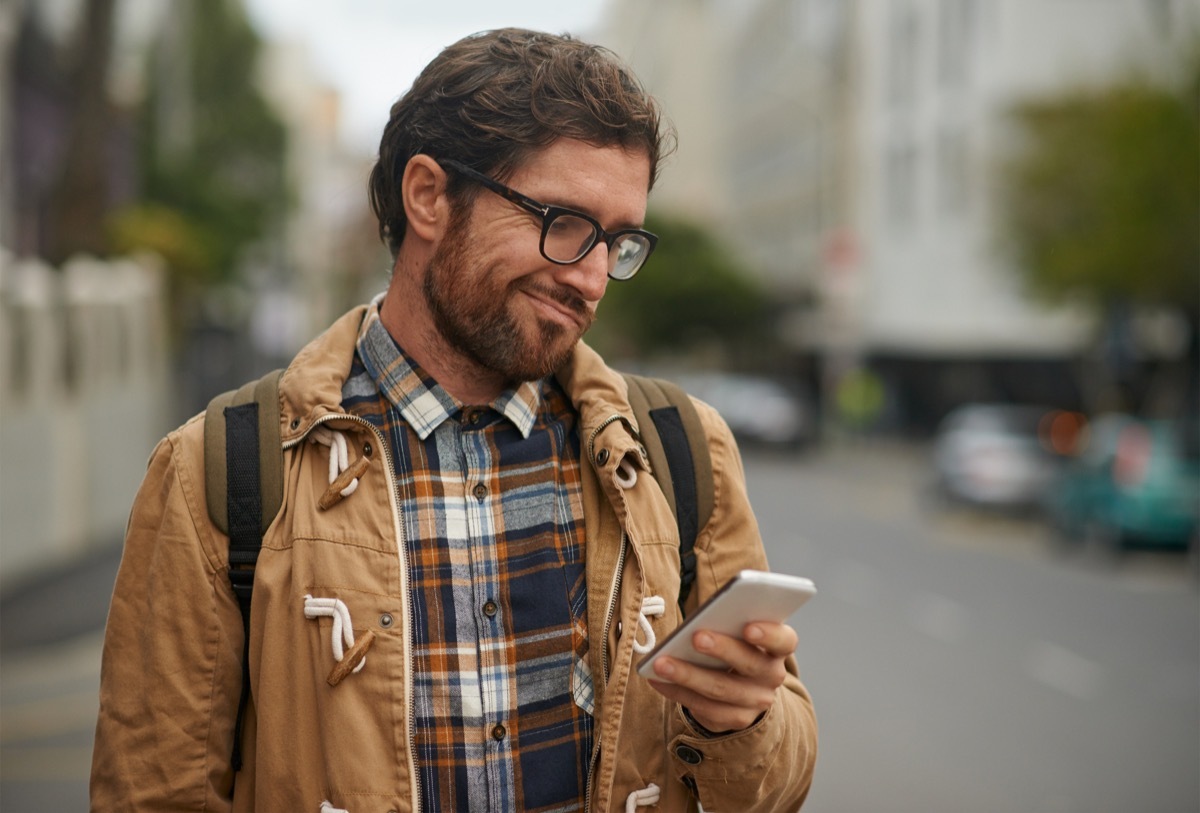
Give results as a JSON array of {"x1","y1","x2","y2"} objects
[{"x1": 637, "y1": 571, "x2": 817, "y2": 680}]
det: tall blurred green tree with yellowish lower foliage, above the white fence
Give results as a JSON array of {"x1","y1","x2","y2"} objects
[{"x1": 112, "y1": 0, "x2": 288, "y2": 296}]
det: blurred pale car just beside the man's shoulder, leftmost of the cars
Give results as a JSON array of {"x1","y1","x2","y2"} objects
[{"x1": 673, "y1": 372, "x2": 816, "y2": 448}]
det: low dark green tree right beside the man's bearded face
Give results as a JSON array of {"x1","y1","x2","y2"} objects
[{"x1": 588, "y1": 215, "x2": 772, "y2": 359}]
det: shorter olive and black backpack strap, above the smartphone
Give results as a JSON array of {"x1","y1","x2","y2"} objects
[{"x1": 624, "y1": 373, "x2": 714, "y2": 609}]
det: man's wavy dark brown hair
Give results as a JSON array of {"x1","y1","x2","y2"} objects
[{"x1": 368, "y1": 29, "x2": 674, "y2": 258}]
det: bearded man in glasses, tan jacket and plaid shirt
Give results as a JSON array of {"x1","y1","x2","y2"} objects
[{"x1": 92, "y1": 30, "x2": 816, "y2": 813}]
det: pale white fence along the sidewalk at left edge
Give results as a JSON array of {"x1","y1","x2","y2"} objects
[{"x1": 0, "y1": 254, "x2": 169, "y2": 586}]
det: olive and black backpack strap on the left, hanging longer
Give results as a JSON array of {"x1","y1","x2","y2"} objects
[{"x1": 204, "y1": 371, "x2": 283, "y2": 771}]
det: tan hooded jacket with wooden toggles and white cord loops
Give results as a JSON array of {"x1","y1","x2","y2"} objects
[{"x1": 91, "y1": 308, "x2": 816, "y2": 813}]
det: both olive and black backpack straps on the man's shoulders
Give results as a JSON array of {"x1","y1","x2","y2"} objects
[{"x1": 204, "y1": 369, "x2": 713, "y2": 771}]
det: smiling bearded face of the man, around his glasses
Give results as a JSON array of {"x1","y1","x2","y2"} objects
[{"x1": 424, "y1": 139, "x2": 650, "y2": 383}]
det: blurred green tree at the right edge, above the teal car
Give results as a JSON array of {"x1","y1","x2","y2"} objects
[{"x1": 1000, "y1": 44, "x2": 1200, "y2": 414}]
